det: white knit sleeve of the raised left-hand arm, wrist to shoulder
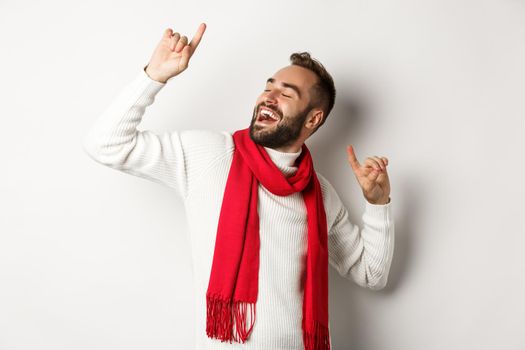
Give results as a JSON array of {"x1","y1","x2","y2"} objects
[{"x1": 82, "y1": 67, "x2": 232, "y2": 199}]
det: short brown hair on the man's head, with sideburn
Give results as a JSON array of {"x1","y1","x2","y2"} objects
[{"x1": 290, "y1": 52, "x2": 335, "y2": 134}]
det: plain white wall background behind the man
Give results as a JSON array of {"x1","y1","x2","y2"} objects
[{"x1": 0, "y1": 0, "x2": 525, "y2": 350}]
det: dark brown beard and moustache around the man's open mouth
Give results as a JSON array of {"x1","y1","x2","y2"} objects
[{"x1": 250, "y1": 103, "x2": 311, "y2": 148}]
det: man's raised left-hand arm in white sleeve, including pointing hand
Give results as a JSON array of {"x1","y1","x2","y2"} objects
[{"x1": 83, "y1": 24, "x2": 213, "y2": 198}]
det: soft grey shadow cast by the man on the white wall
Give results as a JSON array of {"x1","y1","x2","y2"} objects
[{"x1": 309, "y1": 89, "x2": 420, "y2": 350}]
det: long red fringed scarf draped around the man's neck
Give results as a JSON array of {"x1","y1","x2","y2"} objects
[{"x1": 206, "y1": 129, "x2": 330, "y2": 350}]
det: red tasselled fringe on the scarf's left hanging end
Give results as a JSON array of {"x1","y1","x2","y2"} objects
[{"x1": 206, "y1": 295, "x2": 255, "y2": 344}]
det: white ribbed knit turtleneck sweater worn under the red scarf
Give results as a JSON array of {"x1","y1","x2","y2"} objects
[{"x1": 83, "y1": 68, "x2": 394, "y2": 350}]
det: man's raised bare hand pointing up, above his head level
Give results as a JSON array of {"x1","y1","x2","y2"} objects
[{"x1": 146, "y1": 23, "x2": 206, "y2": 83}]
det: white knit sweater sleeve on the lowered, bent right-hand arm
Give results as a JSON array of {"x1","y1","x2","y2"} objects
[{"x1": 316, "y1": 174, "x2": 394, "y2": 290}]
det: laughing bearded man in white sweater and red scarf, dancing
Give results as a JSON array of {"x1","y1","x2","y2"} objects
[{"x1": 84, "y1": 23, "x2": 394, "y2": 349}]
